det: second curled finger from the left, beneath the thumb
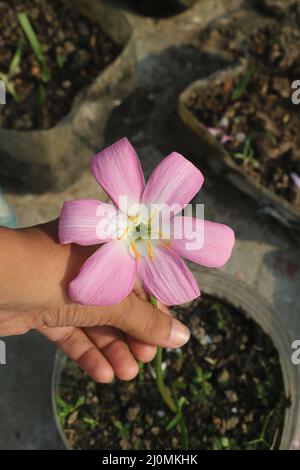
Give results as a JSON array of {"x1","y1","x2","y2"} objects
[{"x1": 84, "y1": 326, "x2": 138, "y2": 380}]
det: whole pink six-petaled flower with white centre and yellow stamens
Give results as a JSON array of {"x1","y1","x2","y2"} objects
[{"x1": 59, "y1": 138, "x2": 234, "y2": 305}]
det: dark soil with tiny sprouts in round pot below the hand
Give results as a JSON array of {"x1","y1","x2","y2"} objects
[{"x1": 57, "y1": 295, "x2": 288, "y2": 450}]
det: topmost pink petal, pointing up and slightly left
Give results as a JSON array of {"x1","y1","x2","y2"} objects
[{"x1": 91, "y1": 138, "x2": 145, "y2": 207}]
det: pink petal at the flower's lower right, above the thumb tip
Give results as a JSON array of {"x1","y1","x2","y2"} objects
[{"x1": 137, "y1": 245, "x2": 200, "y2": 305}]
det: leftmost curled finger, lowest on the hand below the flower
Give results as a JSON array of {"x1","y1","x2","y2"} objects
[{"x1": 41, "y1": 327, "x2": 114, "y2": 383}]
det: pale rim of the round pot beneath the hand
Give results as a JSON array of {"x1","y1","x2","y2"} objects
[{"x1": 52, "y1": 268, "x2": 300, "y2": 449}]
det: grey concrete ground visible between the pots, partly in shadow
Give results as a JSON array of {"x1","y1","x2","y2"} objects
[{"x1": 0, "y1": 0, "x2": 300, "y2": 449}]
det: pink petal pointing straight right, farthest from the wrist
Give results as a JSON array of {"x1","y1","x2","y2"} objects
[{"x1": 171, "y1": 216, "x2": 235, "y2": 268}]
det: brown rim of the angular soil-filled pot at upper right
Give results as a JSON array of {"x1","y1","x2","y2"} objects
[{"x1": 178, "y1": 61, "x2": 300, "y2": 232}]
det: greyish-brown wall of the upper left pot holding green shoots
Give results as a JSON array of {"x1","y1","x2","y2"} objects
[{"x1": 0, "y1": 0, "x2": 137, "y2": 192}]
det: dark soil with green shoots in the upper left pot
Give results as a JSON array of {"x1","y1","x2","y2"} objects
[{"x1": 0, "y1": 0, "x2": 120, "y2": 130}]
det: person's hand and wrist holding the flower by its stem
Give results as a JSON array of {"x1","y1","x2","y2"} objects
[{"x1": 0, "y1": 222, "x2": 189, "y2": 382}]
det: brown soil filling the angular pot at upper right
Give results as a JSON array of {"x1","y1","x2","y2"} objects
[{"x1": 188, "y1": 24, "x2": 300, "y2": 207}]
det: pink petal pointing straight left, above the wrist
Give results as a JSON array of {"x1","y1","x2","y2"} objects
[{"x1": 58, "y1": 199, "x2": 117, "y2": 245}]
